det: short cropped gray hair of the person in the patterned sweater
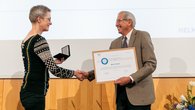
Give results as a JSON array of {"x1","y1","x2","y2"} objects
[{"x1": 29, "y1": 5, "x2": 51, "y2": 23}]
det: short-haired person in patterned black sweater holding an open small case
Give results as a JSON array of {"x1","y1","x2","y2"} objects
[{"x1": 20, "y1": 5, "x2": 83, "y2": 110}]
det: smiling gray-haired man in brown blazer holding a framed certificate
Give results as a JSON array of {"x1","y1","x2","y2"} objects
[{"x1": 83, "y1": 11, "x2": 157, "y2": 110}]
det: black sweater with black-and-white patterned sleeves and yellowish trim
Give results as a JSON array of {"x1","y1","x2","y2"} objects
[{"x1": 21, "y1": 34, "x2": 74, "y2": 95}]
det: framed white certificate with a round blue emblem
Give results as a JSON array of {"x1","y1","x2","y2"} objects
[{"x1": 93, "y1": 47, "x2": 138, "y2": 83}]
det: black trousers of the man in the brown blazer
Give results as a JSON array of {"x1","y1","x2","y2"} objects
[{"x1": 116, "y1": 85, "x2": 151, "y2": 110}]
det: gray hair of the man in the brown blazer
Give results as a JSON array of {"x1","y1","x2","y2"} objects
[{"x1": 120, "y1": 11, "x2": 136, "y2": 27}]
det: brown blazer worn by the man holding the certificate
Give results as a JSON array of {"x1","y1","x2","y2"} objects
[{"x1": 88, "y1": 29, "x2": 157, "y2": 105}]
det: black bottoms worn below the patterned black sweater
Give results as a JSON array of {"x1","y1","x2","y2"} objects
[{"x1": 20, "y1": 90, "x2": 45, "y2": 110}]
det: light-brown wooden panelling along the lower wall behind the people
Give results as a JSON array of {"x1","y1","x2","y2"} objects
[{"x1": 0, "y1": 78, "x2": 195, "y2": 110}]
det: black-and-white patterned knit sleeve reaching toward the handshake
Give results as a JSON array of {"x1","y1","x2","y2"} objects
[{"x1": 34, "y1": 37, "x2": 74, "y2": 78}]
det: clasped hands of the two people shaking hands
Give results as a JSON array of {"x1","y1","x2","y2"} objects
[{"x1": 74, "y1": 70, "x2": 89, "y2": 81}]
